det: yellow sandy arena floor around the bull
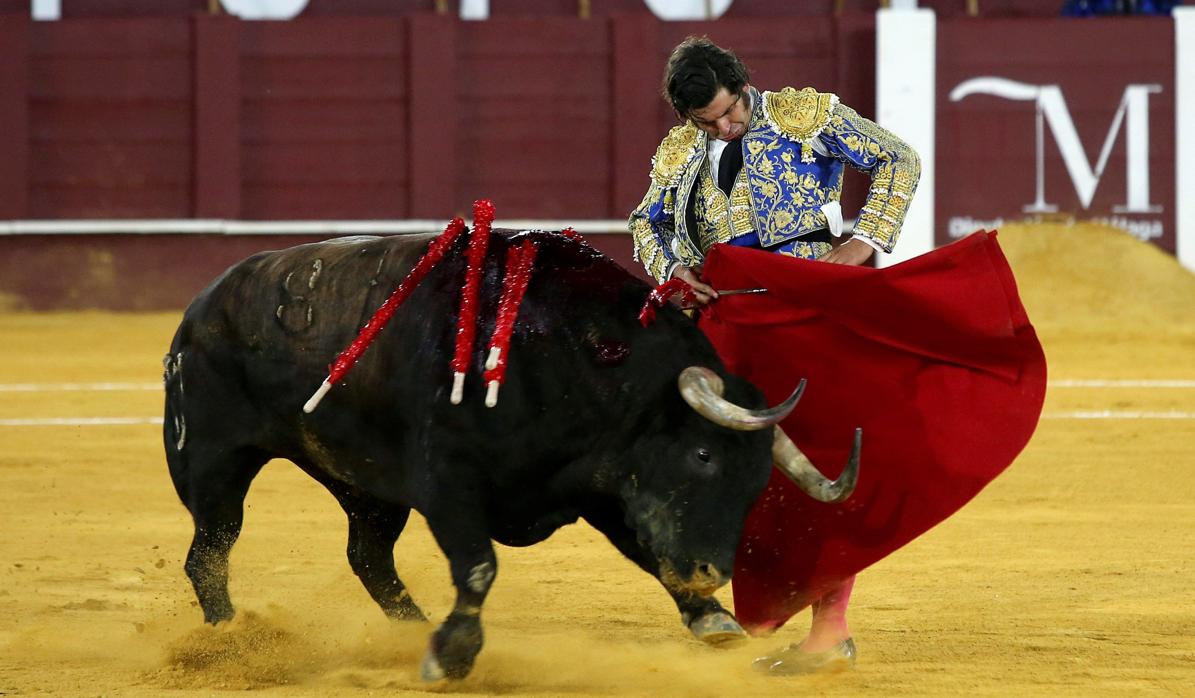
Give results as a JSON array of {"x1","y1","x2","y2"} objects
[{"x1": 0, "y1": 226, "x2": 1195, "y2": 697}]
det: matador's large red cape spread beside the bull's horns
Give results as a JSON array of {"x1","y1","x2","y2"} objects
[{"x1": 700, "y1": 233, "x2": 1046, "y2": 632}]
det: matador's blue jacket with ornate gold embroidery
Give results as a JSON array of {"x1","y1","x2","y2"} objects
[{"x1": 629, "y1": 87, "x2": 921, "y2": 282}]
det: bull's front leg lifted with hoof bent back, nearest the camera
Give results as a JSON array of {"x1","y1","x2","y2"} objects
[{"x1": 419, "y1": 508, "x2": 498, "y2": 681}]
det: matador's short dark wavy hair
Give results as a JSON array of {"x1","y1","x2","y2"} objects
[{"x1": 663, "y1": 36, "x2": 750, "y2": 118}]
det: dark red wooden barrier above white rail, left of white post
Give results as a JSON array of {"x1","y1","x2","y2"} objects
[{"x1": 0, "y1": 14, "x2": 875, "y2": 220}]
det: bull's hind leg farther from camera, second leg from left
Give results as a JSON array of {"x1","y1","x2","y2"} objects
[{"x1": 320, "y1": 478, "x2": 427, "y2": 620}]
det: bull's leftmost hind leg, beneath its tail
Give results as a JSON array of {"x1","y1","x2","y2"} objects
[{"x1": 167, "y1": 447, "x2": 268, "y2": 624}]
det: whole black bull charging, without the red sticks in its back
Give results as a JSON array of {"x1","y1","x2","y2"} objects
[{"x1": 164, "y1": 231, "x2": 854, "y2": 679}]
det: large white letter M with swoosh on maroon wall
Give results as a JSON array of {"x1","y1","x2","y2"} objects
[{"x1": 950, "y1": 78, "x2": 1162, "y2": 213}]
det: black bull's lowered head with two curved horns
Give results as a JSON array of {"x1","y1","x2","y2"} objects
[{"x1": 624, "y1": 366, "x2": 859, "y2": 596}]
